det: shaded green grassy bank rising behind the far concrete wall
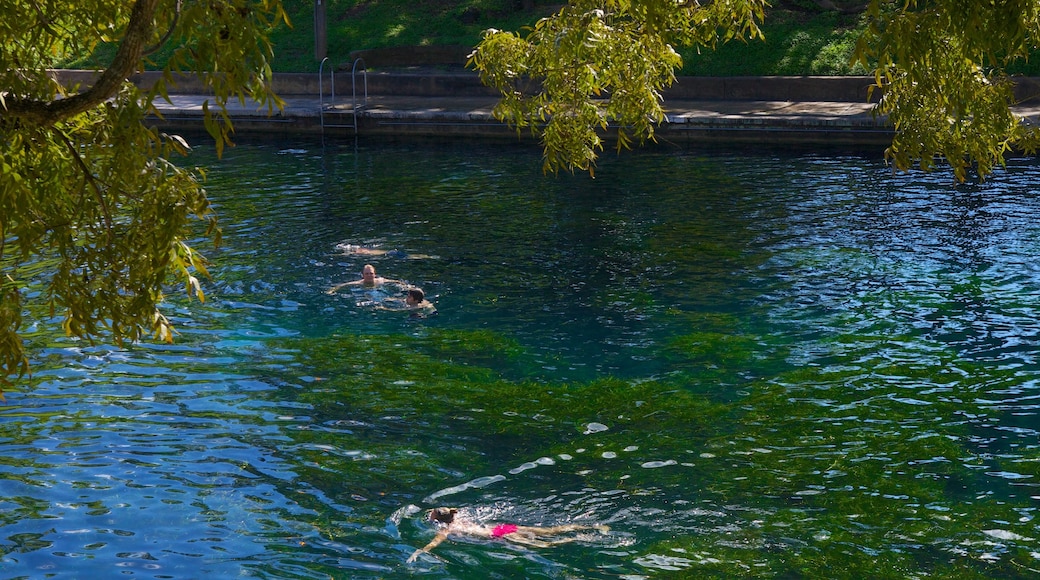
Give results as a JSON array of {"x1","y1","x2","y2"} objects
[{"x1": 66, "y1": 0, "x2": 859, "y2": 76}]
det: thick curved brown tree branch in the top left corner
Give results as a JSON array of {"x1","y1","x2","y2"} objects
[{"x1": 0, "y1": 0, "x2": 159, "y2": 126}]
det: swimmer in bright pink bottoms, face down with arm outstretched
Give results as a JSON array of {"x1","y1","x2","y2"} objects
[{"x1": 408, "y1": 507, "x2": 610, "y2": 562}]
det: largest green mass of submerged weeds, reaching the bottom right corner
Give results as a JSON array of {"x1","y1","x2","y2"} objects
[{"x1": 270, "y1": 322, "x2": 1040, "y2": 578}]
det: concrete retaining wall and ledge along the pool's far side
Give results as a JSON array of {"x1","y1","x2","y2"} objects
[{"x1": 54, "y1": 71, "x2": 1040, "y2": 146}]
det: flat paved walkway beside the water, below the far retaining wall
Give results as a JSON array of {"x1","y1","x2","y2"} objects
[{"x1": 151, "y1": 90, "x2": 891, "y2": 144}]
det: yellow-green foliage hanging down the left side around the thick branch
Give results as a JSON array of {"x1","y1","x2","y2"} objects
[{"x1": 0, "y1": 0, "x2": 285, "y2": 386}]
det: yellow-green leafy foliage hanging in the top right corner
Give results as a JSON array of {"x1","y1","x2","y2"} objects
[{"x1": 857, "y1": 0, "x2": 1040, "y2": 181}]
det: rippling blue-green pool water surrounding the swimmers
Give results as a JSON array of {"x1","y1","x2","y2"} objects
[{"x1": 0, "y1": 135, "x2": 1040, "y2": 579}]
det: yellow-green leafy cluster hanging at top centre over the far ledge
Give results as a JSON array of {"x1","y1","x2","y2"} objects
[{"x1": 470, "y1": 0, "x2": 765, "y2": 176}]
